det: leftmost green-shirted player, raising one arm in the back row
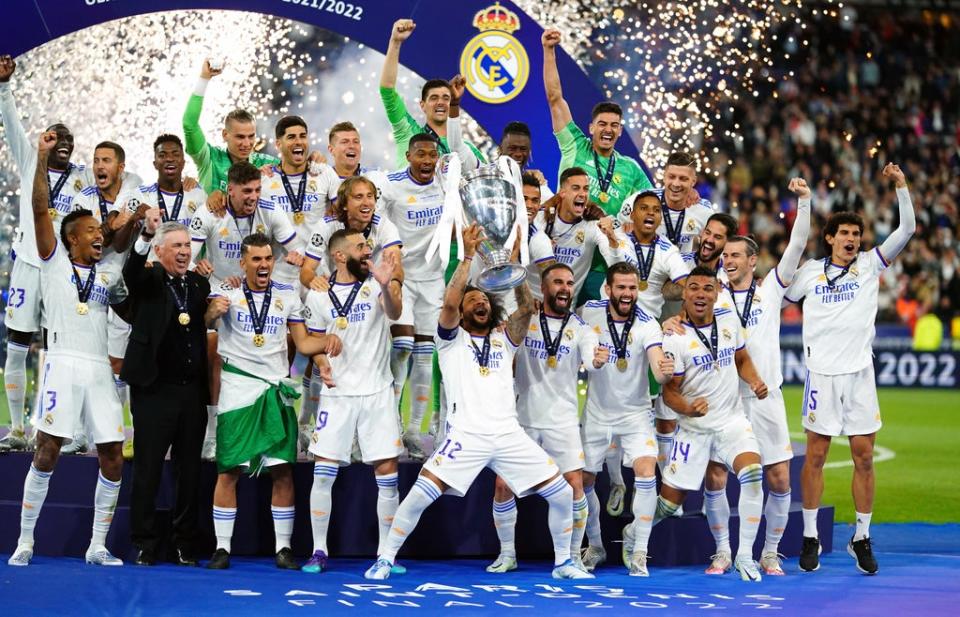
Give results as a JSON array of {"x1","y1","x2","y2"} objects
[{"x1": 183, "y1": 59, "x2": 280, "y2": 195}]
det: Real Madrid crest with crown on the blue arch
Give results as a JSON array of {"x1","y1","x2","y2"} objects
[{"x1": 460, "y1": 2, "x2": 530, "y2": 104}]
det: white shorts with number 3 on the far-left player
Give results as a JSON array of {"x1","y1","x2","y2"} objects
[{"x1": 30, "y1": 351, "x2": 124, "y2": 443}]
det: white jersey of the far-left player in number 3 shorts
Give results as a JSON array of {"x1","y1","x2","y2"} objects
[{"x1": 40, "y1": 239, "x2": 127, "y2": 362}]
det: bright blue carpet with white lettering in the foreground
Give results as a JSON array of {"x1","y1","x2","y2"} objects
[{"x1": 0, "y1": 524, "x2": 960, "y2": 617}]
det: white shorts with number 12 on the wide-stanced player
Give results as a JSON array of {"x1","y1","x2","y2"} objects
[{"x1": 423, "y1": 426, "x2": 560, "y2": 497}]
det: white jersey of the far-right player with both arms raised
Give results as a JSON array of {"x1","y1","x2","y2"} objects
[{"x1": 786, "y1": 248, "x2": 889, "y2": 375}]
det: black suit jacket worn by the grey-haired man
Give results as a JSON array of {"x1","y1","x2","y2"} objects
[{"x1": 120, "y1": 244, "x2": 210, "y2": 389}]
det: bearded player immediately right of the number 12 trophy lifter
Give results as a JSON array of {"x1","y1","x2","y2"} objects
[{"x1": 487, "y1": 263, "x2": 609, "y2": 573}]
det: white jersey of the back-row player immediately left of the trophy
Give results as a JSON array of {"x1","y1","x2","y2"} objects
[{"x1": 380, "y1": 170, "x2": 443, "y2": 281}]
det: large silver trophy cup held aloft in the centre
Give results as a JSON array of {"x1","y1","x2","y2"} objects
[{"x1": 437, "y1": 155, "x2": 527, "y2": 293}]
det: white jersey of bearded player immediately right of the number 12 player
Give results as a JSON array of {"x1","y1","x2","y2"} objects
[{"x1": 517, "y1": 313, "x2": 597, "y2": 428}]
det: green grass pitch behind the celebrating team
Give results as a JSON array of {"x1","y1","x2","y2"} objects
[{"x1": 0, "y1": 368, "x2": 960, "y2": 523}]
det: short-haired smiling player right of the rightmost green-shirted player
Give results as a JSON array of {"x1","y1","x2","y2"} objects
[{"x1": 654, "y1": 152, "x2": 717, "y2": 253}]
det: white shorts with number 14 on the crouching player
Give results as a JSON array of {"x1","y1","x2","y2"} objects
[{"x1": 663, "y1": 415, "x2": 760, "y2": 491}]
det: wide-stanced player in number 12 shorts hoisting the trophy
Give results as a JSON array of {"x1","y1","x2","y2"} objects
[{"x1": 364, "y1": 225, "x2": 593, "y2": 579}]
